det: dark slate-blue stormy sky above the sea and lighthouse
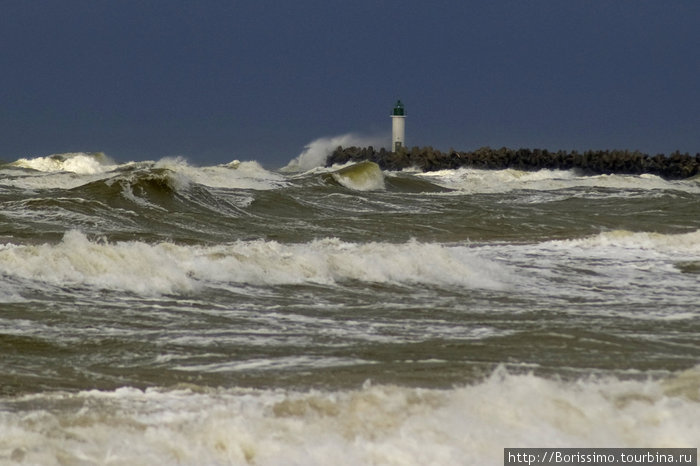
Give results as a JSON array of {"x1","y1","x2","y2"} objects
[{"x1": 0, "y1": 0, "x2": 700, "y2": 168}]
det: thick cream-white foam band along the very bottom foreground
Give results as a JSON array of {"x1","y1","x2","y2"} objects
[{"x1": 0, "y1": 368, "x2": 700, "y2": 466}]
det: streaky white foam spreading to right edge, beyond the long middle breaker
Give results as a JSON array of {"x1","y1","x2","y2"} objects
[{"x1": 492, "y1": 230, "x2": 700, "y2": 314}]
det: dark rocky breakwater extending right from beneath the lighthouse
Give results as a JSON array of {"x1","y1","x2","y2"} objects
[{"x1": 326, "y1": 146, "x2": 700, "y2": 179}]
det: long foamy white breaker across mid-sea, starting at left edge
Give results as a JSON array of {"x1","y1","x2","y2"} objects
[{"x1": 0, "y1": 231, "x2": 508, "y2": 294}]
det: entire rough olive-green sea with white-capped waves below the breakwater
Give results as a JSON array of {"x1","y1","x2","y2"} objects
[{"x1": 0, "y1": 154, "x2": 700, "y2": 465}]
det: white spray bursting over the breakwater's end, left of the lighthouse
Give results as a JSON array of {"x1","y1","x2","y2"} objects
[{"x1": 281, "y1": 133, "x2": 389, "y2": 172}]
